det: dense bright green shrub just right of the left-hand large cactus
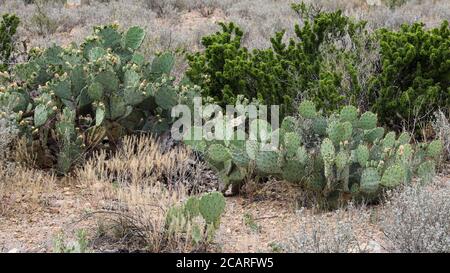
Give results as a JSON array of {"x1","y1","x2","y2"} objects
[{"x1": 186, "y1": 23, "x2": 295, "y2": 113}]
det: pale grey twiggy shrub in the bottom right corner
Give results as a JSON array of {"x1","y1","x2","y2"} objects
[{"x1": 381, "y1": 181, "x2": 450, "y2": 253}]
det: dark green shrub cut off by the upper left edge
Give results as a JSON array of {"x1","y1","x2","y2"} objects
[{"x1": 0, "y1": 14, "x2": 20, "y2": 72}]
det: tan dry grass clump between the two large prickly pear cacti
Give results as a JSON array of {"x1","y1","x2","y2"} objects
[{"x1": 79, "y1": 136, "x2": 214, "y2": 193}]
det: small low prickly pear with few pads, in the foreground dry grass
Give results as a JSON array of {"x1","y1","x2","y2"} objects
[{"x1": 166, "y1": 192, "x2": 225, "y2": 245}]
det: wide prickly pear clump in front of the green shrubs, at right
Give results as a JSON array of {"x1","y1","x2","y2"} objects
[{"x1": 184, "y1": 101, "x2": 442, "y2": 207}]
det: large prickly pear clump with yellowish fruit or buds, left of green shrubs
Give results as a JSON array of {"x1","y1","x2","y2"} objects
[{"x1": 0, "y1": 25, "x2": 195, "y2": 174}]
